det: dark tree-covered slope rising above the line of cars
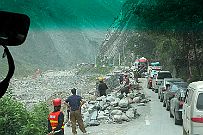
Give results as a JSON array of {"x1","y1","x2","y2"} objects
[{"x1": 100, "y1": 0, "x2": 203, "y2": 81}]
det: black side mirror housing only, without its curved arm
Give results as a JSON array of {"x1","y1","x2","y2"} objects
[{"x1": 0, "y1": 11, "x2": 30, "y2": 46}]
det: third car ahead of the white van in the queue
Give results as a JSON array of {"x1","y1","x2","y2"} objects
[{"x1": 158, "y1": 78, "x2": 183, "y2": 102}]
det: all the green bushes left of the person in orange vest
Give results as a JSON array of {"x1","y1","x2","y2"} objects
[{"x1": 0, "y1": 96, "x2": 49, "y2": 135}]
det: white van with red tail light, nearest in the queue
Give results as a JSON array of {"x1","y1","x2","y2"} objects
[{"x1": 182, "y1": 81, "x2": 203, "y2": 135}]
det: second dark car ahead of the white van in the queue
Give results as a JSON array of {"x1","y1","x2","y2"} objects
[{"x1": 163, "y1": 82, "x2": 188, "y2": 111}]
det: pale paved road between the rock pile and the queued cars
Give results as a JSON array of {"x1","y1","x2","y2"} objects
[{"x1": 123, "y1": 78, "x2": 182, "y2": 135}]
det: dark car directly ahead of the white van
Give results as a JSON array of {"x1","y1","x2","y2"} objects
[{"x1": 170, "y1": 88, "x2": 187, "y2": 125}]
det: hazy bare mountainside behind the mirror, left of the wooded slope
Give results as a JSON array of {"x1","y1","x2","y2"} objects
[{"x1": 0, "y1": 0, "x2": 122, "y2": 76}]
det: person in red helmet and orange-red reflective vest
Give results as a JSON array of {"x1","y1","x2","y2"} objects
[{"x1": 48, "y1": 98, "x2": 64, "y2": 135}]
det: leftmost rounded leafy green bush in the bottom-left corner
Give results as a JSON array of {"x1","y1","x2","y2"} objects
[{"x1": 0, "y1": 97, "x2": 29, "y2": 135}]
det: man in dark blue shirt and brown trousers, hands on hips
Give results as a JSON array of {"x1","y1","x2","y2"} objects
[{"x1": 65, "y1": 88, "x2": 87, "y2": 135}]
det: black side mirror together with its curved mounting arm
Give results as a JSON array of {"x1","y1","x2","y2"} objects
[{"x1": 0, "y1": 11, "x2": 30, "y2": 98}]
